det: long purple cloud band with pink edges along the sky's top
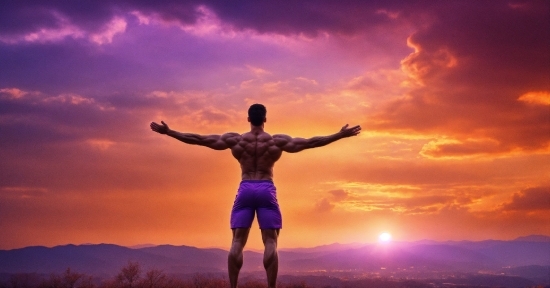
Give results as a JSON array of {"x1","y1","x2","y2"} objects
[{"x1": 0, "y1": 0, "x2": 429, "y2": 44}]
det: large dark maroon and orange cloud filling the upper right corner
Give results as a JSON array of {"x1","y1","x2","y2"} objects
[{"x1": 369, "y1": 1, "x2": 550, "y2": 157}]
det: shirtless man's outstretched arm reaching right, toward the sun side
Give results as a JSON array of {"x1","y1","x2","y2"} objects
[{"x1": 273, "y1": 124, "x2": 361, "y2": 153}]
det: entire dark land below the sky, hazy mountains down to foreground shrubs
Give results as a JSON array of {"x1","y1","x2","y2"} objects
[{"x1": 0, "y1": 235, "x2": 550, "y2": 288}]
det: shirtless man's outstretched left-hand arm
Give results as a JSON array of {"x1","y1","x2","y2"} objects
[{"x1": 150, "y1": 121, "x2": 240, "y2": 150}]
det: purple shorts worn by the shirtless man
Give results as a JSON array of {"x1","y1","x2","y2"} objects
[{"x1": 231, "y1": 180, "x2": 283, "y2": 229}]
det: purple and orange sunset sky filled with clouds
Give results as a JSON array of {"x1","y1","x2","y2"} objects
[{"x1": 0, "y1": 0, "x2": 550, "y2": 249}]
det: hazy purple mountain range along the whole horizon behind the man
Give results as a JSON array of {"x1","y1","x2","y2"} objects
[{"x1": 0, "y1": 235, "x2": 550, "y2": 278}]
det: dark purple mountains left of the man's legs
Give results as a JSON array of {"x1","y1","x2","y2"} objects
[{"x1": 0, "y1": 244, "x2": 233, "y2": 277}]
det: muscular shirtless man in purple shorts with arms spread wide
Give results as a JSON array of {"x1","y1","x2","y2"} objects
[{"x1": 151, "y1": 104, "x2": 361, "y2": 288}]
